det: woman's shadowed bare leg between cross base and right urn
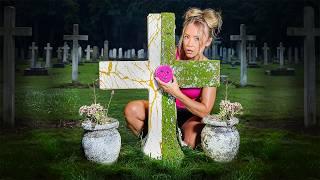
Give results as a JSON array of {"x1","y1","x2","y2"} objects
[{"x1": 182, "y1": 116, "x2": 204, "y2": 148}]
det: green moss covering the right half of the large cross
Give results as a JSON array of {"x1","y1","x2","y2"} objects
[{"x1": 161, "y1": 13, "x2": 220, "y2": 163}]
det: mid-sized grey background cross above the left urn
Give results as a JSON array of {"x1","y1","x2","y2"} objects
[{"x1": 63, "y1": 24, "x2": 88, "y2": 82}]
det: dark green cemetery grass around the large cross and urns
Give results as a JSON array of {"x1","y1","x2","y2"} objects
[{"x1": 0, "y1": 63, "x2": 320, "y2": 179}]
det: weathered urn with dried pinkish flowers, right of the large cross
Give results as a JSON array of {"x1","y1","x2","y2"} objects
[{"x1": 201, "y1": 81, "x2": 242, "y2": 162}]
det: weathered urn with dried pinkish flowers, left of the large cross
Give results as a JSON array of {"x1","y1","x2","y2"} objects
[{"x1": 79, "y1": 81, "x2": 121, "y2": 164}]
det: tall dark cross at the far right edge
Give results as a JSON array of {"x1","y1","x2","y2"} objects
[{"x1": 287, "y1": 6, "x2": 320, "y2": 127}]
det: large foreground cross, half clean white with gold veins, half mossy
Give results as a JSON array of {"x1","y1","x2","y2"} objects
[{"x1": 99, "y1": 13, "x2": 220, "y2": 162}]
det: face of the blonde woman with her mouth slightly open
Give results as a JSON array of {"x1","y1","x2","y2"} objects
[{"x1": 183, "y1": 23, "x2": 210, "y2": 60}]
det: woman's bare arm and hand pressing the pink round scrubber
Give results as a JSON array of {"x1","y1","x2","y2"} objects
[{"x1": 156, "y1": 77, "x2": 217, "y2": 118}]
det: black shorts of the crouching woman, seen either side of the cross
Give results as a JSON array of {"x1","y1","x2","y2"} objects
[{"x1": 140, "y1": 108, "x2": 194, "y2": 137}]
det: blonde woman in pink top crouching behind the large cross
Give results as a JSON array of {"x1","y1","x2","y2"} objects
[{"x1": 124, "y1": 8, "x2": 222, "y2": 148}]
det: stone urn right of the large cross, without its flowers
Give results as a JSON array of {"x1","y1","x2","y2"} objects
[{"x1": 201, "y1": 115, "x2": 240, "y2": 162}]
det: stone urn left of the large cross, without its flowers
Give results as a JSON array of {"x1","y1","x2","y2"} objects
[{"x1": 82, "y1": 118, "x2": 121, "y2": 164}]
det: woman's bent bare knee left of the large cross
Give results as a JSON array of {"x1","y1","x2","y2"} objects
[{"x1": 124, "y1": 100, "x2": 149, "y2": 136}]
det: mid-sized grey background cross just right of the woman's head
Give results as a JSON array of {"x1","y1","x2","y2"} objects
[{"x1": 230, "y1": 24, "x2": 256, "y2": 86}]
